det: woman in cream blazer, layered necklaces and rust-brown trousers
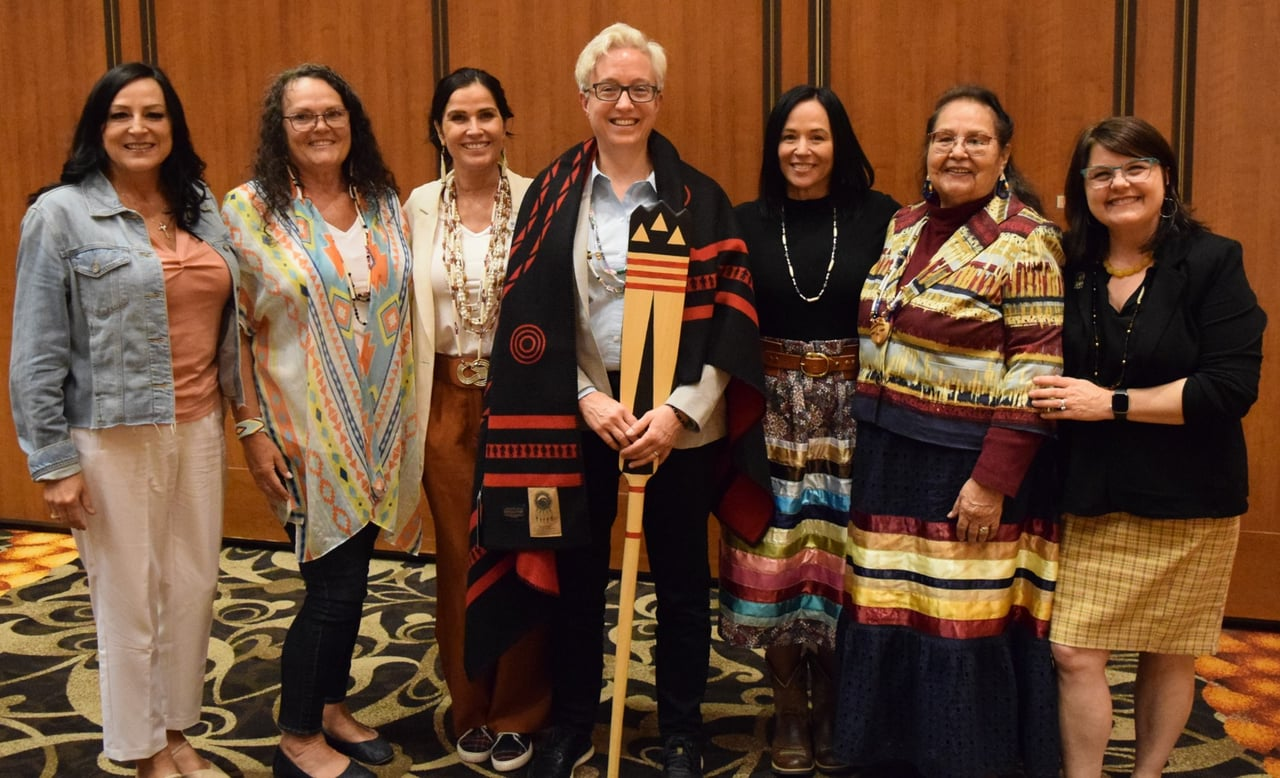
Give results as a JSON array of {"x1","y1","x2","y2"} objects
[{"x1": 404, "y1": 68, "x2": 550, "y2": 773}]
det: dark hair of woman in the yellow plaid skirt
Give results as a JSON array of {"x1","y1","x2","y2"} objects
[{"x1": 1062, "y1": 116, "x2": 1204, "y2": 262}]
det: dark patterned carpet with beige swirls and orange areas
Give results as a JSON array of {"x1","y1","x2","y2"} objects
[{"x1": 0, "y1": 530, "x2": 1280, "y2": 778}]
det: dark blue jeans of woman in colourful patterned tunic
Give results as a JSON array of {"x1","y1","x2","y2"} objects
[{"x1": 278, "y1": 523, "x2": 378, "y2": 736}]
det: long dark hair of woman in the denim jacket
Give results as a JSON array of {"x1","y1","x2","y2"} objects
[{"x1": 27, "y1": 63, "x2": 205, "y2": 229}]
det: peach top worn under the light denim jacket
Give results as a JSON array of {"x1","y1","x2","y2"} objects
[{"x1": 155, "y1": 229, "x2": 232, "y2": 424}]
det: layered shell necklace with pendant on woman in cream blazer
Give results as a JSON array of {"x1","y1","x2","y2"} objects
[{"x1": 442, "y1": 171, "x2": 511, "y2": 386}]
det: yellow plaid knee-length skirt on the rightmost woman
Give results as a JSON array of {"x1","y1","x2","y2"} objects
[{"x1": 1050, "y1": 513, "x2": 1240, "y2": 656}]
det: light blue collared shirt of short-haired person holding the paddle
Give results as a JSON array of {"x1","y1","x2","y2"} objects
[{"x1": 579, "y1": 163, "x2": 658, "y2": 370}]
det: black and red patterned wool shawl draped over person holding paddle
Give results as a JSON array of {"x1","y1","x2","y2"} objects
[{"x1": 466, "y1": 133, "x2": 772, "y2": 673}]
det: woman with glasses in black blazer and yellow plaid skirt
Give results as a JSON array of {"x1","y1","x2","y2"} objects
[{"x1": 1032, "y1": 116, "x2": 1266, "y2": 778}]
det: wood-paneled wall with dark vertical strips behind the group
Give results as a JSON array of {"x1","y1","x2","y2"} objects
[{"x1": 0, "y1": 0, "x2": 1280, "y2": 619}]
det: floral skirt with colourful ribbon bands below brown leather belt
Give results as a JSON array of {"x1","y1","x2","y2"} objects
[{"x1": 719, "y1": 340, "x2": 855, "y2": 649}]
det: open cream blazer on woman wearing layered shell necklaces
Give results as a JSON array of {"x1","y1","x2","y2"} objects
[{"x1": 404, "y1": 169, "x2": 532, "y2": 434}]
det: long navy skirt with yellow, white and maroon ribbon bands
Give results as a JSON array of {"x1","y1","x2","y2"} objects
[{"x1": 836, "y1": 424, "x2": 1059, "y2": 778}]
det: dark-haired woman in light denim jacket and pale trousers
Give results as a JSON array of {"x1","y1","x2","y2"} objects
[{"x1": 9, "y1": 63, "x2": 243, "y2": 778}]
